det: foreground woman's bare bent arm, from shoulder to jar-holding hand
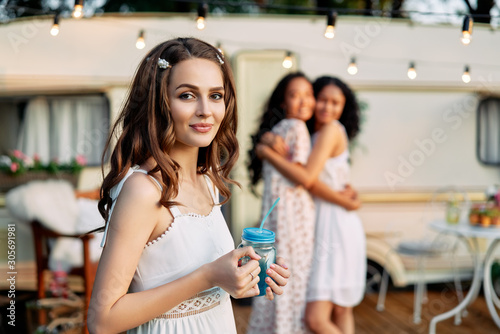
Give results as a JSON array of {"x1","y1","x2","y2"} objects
[{"x1": 88, "y1": 176, "x2": 260, "y2": 333}]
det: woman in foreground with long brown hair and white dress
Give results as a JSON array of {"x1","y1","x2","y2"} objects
[{"x1": 87, "y1": 38, "x2": 290, "y2": 333}]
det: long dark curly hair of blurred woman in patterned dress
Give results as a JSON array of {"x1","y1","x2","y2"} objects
[{"x1": 248, "y1": 72, "x2": 310, "y2": 191}]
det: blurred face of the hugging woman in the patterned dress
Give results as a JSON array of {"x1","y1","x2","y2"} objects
[{"x1": 282, "y1": 77, "x2": 315, "y2": 121}]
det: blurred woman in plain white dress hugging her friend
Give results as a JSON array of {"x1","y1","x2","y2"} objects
[{"x1": 258, "y1": 77, "x2": 366, "y2": 334}]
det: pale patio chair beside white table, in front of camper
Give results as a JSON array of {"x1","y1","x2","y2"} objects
[{"x1": 376, "y1": 187, "x2": 472, "y2": 324}]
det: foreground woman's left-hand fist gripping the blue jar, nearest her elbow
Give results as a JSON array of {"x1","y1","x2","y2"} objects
[{"x1": 205, "y1": 246, "x2": 260, "y2": 298}]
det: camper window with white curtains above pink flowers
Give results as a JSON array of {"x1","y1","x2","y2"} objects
[{"x1": 0, "y1": 94, "x2": 110, "y2": 166}]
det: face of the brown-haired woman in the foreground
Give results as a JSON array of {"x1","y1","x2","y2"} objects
[{"x1": 167, "y1": 58, "x2": 226, "y2": 147}]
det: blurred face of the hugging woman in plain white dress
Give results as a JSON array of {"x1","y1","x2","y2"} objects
[{"x1": 314, "y1": 85, "x2": 345, "y2": 124}]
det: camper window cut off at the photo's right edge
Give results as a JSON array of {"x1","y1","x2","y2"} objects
[{"x1": 477, "y1": 97, "x2": 500, "y2": 166}]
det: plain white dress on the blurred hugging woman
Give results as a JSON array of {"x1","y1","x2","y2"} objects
[{"x1": 307, "y1": 121, "x2": 366, "y2": 307}]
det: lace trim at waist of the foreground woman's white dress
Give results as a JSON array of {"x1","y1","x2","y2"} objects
[{"x1": 155, "y1": 286, "x2": 223, "y2": 319}]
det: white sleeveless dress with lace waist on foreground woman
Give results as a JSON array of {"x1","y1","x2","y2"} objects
[{"x1": 102, "y1": 167, "x2": 236, "y2": 334}]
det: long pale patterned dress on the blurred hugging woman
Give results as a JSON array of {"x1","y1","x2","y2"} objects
[{"x1": 247, "y1": 119, "x2": 315, "y2": 334}]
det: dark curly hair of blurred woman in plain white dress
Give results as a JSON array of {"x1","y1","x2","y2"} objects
[{"x1": 307, "y1": 76, "x2": 360, "y2": 140}]
